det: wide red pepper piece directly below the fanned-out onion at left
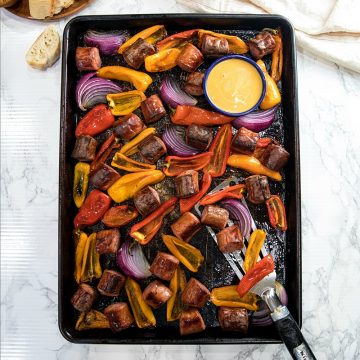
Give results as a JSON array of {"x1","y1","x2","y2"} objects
[{"x1": 75, "y1": 104, "x2": 115, "y2": 137}]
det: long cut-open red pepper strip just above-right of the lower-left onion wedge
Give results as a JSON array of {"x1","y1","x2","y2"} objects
[{"x1": 130, "y1": 197, "x2": 178, "y2": 245}]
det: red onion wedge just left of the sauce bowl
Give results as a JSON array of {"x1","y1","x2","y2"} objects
[{"x1": 160, "y1": 76, "x2": 197, "y2": 109}]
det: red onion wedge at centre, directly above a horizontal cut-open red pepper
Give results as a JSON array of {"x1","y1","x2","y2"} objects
[{"x1": 162, "y1": 126, "x2": 201, "y2": 156}]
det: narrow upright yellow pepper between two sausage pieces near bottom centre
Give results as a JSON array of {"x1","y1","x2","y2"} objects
[{"x1": 166, "y1": 266, "x2": 186, "y2": 321}]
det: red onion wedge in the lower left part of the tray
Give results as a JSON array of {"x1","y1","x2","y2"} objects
[{"x1": 116, "y1": 239, "x2": 151, "y2": 280}]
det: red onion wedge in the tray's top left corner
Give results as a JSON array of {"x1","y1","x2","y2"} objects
[{"x1": 84, "y1": 30, "x2": 130, "y2": 55}]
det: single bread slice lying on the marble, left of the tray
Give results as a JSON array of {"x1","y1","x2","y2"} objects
[{"x1": 26, "y1": 25, "x2": 60, "y2": 70}]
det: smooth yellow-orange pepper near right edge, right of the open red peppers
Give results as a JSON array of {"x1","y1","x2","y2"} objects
[{"x1": 227, "y1": 154, "x2": 282, "y2": 181}]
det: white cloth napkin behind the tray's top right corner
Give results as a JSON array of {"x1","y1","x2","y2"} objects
[{"x1": 177, "y1": 0, "x2": 360, "y2": 73}]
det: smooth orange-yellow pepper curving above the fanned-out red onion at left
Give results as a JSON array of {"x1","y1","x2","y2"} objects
[{"x1": 96, "y1": 65, "x2": 152, "y2": 91}]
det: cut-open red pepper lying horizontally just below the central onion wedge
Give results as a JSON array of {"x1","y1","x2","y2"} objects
[{"x1": 163, "y1": 152, "x2": 212, "y2": 176}]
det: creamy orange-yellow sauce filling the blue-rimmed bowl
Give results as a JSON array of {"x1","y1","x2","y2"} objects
[{"x1": 206, "y1": 59, "x2": 263, "y2": 114}]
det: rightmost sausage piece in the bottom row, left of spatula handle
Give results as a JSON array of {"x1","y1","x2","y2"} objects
[{"x1": 218, "y1": 306, "x2": 249, "y2": 334}]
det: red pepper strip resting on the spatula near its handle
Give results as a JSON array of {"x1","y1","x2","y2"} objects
[{"x1": 236, "y1": 254, "x2": 275, "y2": 297}]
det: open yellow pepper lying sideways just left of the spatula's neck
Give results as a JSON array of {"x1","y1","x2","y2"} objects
[{"x1": 210, "y1": 285, "x2": 259, "y2": 311}]
